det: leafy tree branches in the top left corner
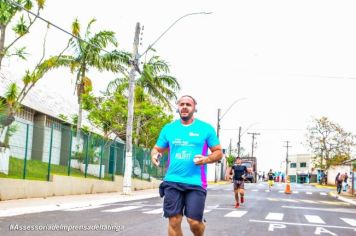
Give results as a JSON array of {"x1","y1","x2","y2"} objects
[{"x1": 0, "y1": 0, "x2": 45, "y2": 70}]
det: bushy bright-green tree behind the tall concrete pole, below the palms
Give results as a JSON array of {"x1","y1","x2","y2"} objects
[{"x1": 83, "y1": 85, "x2": 173, "y2": 147}]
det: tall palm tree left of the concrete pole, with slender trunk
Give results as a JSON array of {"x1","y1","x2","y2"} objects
[{"x1": 47, "y1": 19, "x2": 130, "y2": 151}]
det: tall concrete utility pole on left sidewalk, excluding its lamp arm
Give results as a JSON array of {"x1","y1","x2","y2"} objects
[{"x1": 123, "y1": 22, "x2": 141, "y2": 194}]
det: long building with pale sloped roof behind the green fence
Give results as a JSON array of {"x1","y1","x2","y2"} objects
[{"x1": 0, "y1": 72, "x2": 124, "y2": 177}]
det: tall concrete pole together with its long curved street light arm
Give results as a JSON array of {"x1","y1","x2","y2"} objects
[{"x1": 123, "y1": 12, "x2": 211, "y2": 194}]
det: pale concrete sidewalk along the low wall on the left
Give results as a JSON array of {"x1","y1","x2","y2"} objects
[{"x1": 0, "y1": 189, "x2": 159, "y2": 218}]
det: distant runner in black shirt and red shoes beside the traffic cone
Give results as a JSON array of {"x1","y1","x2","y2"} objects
[{"x1": 227, "y1": 157, "x2": 248, "y2": 208}]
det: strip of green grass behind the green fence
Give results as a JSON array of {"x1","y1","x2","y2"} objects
[{"x1": 0, "y1": 157, "x2": 112, "y2": 181}]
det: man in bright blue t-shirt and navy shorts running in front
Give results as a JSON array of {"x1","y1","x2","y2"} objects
[{"x1": 151, "y1": 95, "x2": 223, "y2": 235}]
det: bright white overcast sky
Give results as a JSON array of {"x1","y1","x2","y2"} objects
[{"x1": 5, "y1": 0, "x2": 356, "y2": 173}]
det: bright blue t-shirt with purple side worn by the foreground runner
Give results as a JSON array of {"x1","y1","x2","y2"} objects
[{"x1": 156, "y1": 119, "x2": 220, "y2": 189}]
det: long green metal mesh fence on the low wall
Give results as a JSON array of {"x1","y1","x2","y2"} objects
[{"x1": 0, "y1": 120, "x2": 167, "y2": 181}]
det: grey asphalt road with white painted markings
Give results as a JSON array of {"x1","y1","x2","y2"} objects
[{"x1": 0, "y1": 182, "x2": 356, "y2": 236}]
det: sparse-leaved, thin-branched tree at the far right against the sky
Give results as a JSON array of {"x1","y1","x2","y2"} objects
[{"x1": 306, "y1": 117, "x2": 355, "y2": 170}]
